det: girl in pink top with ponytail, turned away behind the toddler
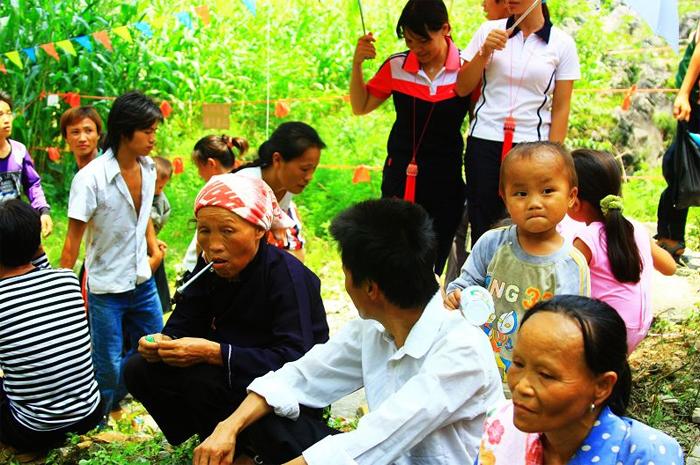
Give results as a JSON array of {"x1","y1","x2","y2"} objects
[{"x1": 569, "y1": 149, "x2": 676, "y2": 353}]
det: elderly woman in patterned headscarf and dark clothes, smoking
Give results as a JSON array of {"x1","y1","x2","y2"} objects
[{"x1": 125, "y1": 174, "x2": 328, "y2": 444}]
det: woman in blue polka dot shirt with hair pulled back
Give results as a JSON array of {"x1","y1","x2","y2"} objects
[{"x1": 476, "y1": 295, "x2": 683, "y2": 465}]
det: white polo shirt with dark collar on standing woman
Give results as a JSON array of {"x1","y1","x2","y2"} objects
[{"x1": 464, "y1": 18, "x2": 581, "y2": 142}]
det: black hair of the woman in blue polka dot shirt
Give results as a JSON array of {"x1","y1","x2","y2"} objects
[{"x1": 520, "y1": 295, "x2": 632, "y2": 415}]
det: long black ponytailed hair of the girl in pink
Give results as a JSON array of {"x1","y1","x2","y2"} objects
[{"x1": 571, "y1": 149, "x2": 643, "y2": 283}]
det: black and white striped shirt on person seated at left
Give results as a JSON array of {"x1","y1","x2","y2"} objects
[{"x1": 0, "y1": 269, "x2": 100, "y2": 431}]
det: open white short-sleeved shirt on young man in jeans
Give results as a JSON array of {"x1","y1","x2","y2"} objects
[{"x1": 68, "y1": 150, "x2": 156, "y2": 294}]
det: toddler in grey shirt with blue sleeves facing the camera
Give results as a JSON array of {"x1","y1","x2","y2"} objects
[{"x1": 445, "y1": 142, "x2": 590, "y2": 372}]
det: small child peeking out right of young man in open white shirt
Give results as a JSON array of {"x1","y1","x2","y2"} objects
[{"x1": 151, "y1": 157, "x2": 173, "y2": 313}]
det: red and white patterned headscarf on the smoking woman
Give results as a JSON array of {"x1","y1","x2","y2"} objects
[{"x1": 194, "y1": 173, "x2": 294, "y2": 231}]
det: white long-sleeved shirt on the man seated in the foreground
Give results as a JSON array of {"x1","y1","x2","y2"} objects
[{"x1": 248, "y1": 293, "x2": 503, "y2": 465}]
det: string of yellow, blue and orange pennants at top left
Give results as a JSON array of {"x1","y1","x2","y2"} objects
[{"x1": 0, "y1": 5, "x2": 213, "y2": 74}]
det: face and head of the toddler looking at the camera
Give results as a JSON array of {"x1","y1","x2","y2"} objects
[{"x1": 501, "y1": 151, "x2": 577, "y2": 234}]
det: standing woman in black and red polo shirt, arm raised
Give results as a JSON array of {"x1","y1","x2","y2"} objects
[{"x1": 350, "y1": 0, "x2": 469, "y2": 274}]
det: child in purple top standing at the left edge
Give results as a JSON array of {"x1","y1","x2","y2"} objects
[{"x1": 0, "y1": 91, "x2": 53, "y2": 269}]
